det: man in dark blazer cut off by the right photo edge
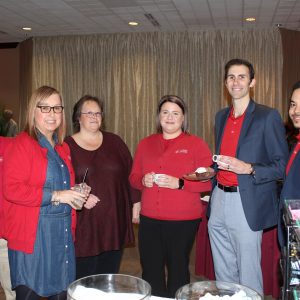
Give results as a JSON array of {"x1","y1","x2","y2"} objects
[{"x1": 278, "y1": 81, "x2": 300, "y2": 246}]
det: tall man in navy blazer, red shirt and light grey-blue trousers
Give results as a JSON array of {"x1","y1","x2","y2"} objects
[{"x1": 208, "y1": 59, "x2": 288, "y2": 295}]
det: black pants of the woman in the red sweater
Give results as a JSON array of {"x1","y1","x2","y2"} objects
[{"x1": 139, "y1": 216, "x2": 201, "y2": 298}]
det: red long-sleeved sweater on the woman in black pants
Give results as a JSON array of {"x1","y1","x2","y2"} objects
[{"x1": 129, "y1": 133, "x2": 212, "y2": 220}]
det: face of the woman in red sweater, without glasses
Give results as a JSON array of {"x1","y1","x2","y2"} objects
[{"x1": 159, "y1": 102, "x2": 184, "y2": 138}]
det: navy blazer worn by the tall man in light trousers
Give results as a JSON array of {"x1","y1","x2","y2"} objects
[{"x1": 208, "y1": 100, "x2": 289, "y2": 231}]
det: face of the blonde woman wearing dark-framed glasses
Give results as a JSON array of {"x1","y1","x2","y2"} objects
[{"x1": 34, "y1": 94, "x2": 63, "y2": 141}]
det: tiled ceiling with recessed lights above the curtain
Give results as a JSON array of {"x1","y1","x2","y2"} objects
[{"x1": 0, "y1": 0, "x2": 300, "y2": 43}]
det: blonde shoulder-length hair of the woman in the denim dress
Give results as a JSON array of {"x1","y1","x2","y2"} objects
[{"x1": 25, "y1": 85, "x2": 66, "y2": 144}]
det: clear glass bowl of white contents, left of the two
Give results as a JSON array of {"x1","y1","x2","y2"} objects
[{"x1": 67, "y1": 274, "x2": 151, "y2": 300}]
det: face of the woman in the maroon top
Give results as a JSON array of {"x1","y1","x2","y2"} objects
[{"x1": 79, "y1": 100, "x2": 102, "y2": 132}]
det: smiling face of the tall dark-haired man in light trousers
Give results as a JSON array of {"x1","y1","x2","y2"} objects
[{"x1": 225, "y1": 65, "x2": 255, "y2": 101}]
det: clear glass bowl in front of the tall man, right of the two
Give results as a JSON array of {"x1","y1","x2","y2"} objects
[{"x1": 175, "y1": 281, "x2": 262, "y2": 300}]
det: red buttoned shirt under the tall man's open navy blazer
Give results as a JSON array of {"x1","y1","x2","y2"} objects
[{"x1": 217, "y1": 108, "x2": 245, "y2": 186}]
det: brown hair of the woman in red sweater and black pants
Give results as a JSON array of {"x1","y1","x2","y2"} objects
[{"x1": 156, "y1": 95, "x2": 188, "y2": 133}]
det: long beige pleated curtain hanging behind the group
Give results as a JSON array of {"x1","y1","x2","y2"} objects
[{"x1": 19, "y1": 29, "x2": 282, "y2": 152}]
